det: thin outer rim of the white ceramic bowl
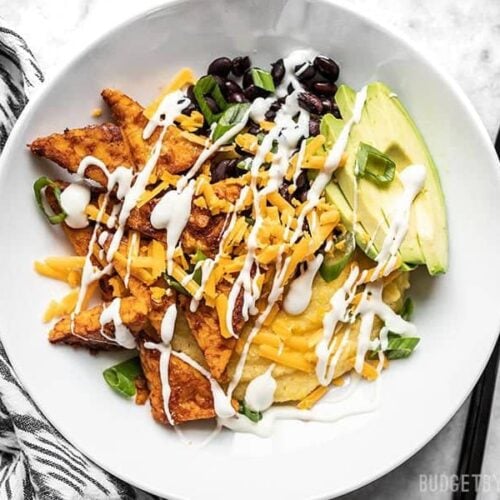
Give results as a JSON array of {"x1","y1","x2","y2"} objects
[{"x1": 0, "y1": 0, "x2": 500, "y2": 500}]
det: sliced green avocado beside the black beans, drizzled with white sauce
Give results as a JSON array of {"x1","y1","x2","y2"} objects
[{"x1": 326, "y1": 82, "x2": 448, "y2": 275}]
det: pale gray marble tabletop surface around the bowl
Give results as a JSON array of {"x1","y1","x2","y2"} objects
[{"x1": 0, "y1": 0, "x2": 500, "y2": 500}]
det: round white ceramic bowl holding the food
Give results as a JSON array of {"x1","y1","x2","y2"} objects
[{"x1": 0, "y1": 0, "x2": 500, "y2": 500}]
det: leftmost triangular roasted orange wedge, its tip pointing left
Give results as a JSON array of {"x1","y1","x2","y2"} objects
[{"x1": 29, "y1": 123, "x2": 133, "y2": 186}]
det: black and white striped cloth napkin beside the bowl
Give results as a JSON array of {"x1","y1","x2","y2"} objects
[{"x1": 0, "y1": 26, "x2": 157, "y2": 500}]
